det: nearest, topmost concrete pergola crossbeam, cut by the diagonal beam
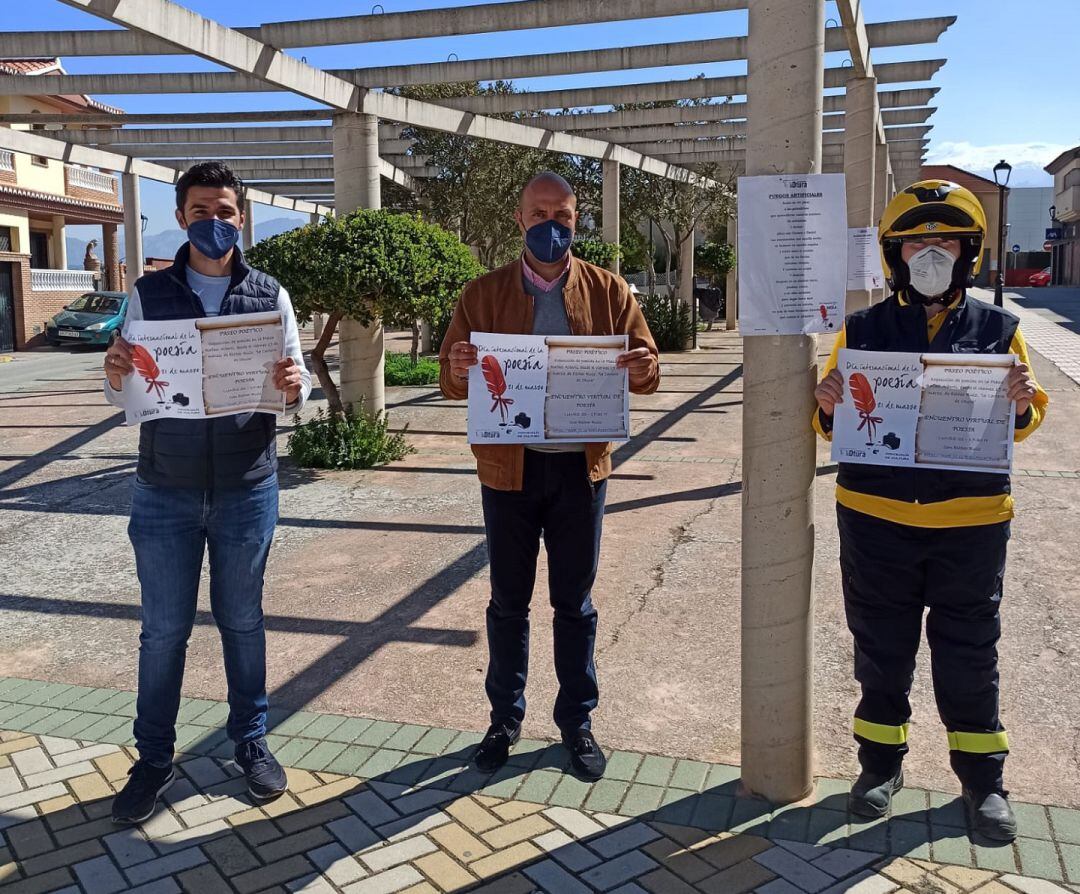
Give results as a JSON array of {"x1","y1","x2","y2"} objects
[{"x1": 0, "y1": 0, "x2": 746, "y2": 57}]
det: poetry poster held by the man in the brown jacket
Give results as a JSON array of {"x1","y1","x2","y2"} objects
[{"x1": 469, "y1": 333, "x2": 630, "y2": 444}]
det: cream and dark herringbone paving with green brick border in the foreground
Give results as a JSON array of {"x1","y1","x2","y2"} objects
[{"x1": 0, "y1": 678, "x2": 1080, "y2": 894}]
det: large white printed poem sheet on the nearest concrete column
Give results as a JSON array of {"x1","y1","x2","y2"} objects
[{"x1": 739, "y1": 174, "x2": 848, "y2": 335}]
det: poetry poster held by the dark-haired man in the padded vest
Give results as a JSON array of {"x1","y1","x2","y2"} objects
[{"x1": 122, "y1": 313, "x2": 285, "y2": 424}]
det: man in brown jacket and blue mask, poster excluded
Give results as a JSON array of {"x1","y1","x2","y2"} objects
[{"x1": 440, "y1": 172, "x2": 660, "y2": 780}]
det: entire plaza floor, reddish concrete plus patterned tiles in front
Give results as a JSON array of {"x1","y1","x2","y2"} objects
[{"x1": 0, "y1": 290, "x2": 1080, "y2": 894}]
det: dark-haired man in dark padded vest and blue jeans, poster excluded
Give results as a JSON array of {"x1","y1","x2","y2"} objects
[{"x1": 105, "y1": 162, "x2": 311, "y2": 824}]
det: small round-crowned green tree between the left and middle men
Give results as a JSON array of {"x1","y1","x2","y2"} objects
[{"x1": 247, "y1": 208, "x2": 484, "y2": 412}]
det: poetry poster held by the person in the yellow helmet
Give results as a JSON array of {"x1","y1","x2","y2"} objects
[{"x1": 833, "y1": 349, "x2": 1016, "y2": 474}]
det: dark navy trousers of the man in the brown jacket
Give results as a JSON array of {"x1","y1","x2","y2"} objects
[{"x1": 483, "y1": 450, "x2": 607, "y2": 735}]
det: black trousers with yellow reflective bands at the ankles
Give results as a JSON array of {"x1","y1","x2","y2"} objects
[{"x1": 837, "y1": 506, "x2": 1009, "y2": 791}]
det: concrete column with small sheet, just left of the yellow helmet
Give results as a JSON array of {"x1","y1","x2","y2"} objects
[{"x1": 843, "y1": 78, "x2": 878, "y2": 313}]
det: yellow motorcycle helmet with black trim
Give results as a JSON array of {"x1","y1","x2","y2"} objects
[{"x1": 878, "y1": 180, "x2": 986, "y2": 293}]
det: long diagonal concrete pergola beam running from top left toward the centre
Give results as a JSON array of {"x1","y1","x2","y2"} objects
[{"x1": 48, "y1": 0, "x2": 708, "y2": 184}]
